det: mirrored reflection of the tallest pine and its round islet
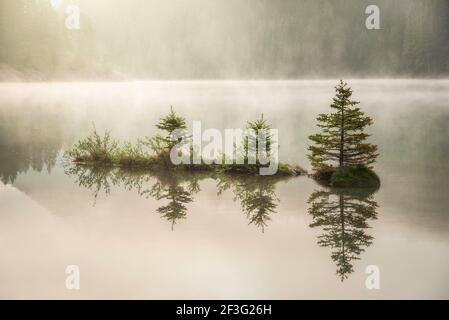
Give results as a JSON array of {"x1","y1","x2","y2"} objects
[{"x1": 308, "y1": 189, "x2": 378, "y2": 281}]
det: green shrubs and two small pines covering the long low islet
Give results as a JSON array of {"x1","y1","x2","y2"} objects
[{"x1": 66, "y1": 109, "x2": 306, "y2": 176}]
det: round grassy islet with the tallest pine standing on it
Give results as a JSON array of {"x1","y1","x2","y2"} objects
[{"x1": 308, "y1": 80, "x2": 380, "y2": 188}]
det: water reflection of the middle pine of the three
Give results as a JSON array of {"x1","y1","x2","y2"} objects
[{"x1": 217, "y1": 175, "x2": 285, "y2": 232}]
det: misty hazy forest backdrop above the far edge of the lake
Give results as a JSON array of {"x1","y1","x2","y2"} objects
[{"x1": 0, "y1": 0, "x2": 449, "y2": 81}]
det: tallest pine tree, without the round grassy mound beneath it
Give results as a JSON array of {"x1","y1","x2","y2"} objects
[{"x1": 308, "y1": 80, "x2": 378, "y2": 171}]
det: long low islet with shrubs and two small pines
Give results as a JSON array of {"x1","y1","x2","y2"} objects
[{"x1": 65, "y1": 108, "x2": 307, "y2": 177}]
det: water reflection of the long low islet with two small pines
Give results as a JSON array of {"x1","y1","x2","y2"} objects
[{"x1": 65, "y1": 165, "x2": 288, "y2": 232}]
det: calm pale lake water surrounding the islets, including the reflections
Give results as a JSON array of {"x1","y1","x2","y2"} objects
[{"x1": 0, "y1": 80, "x2": 449, "y2": 299}]
